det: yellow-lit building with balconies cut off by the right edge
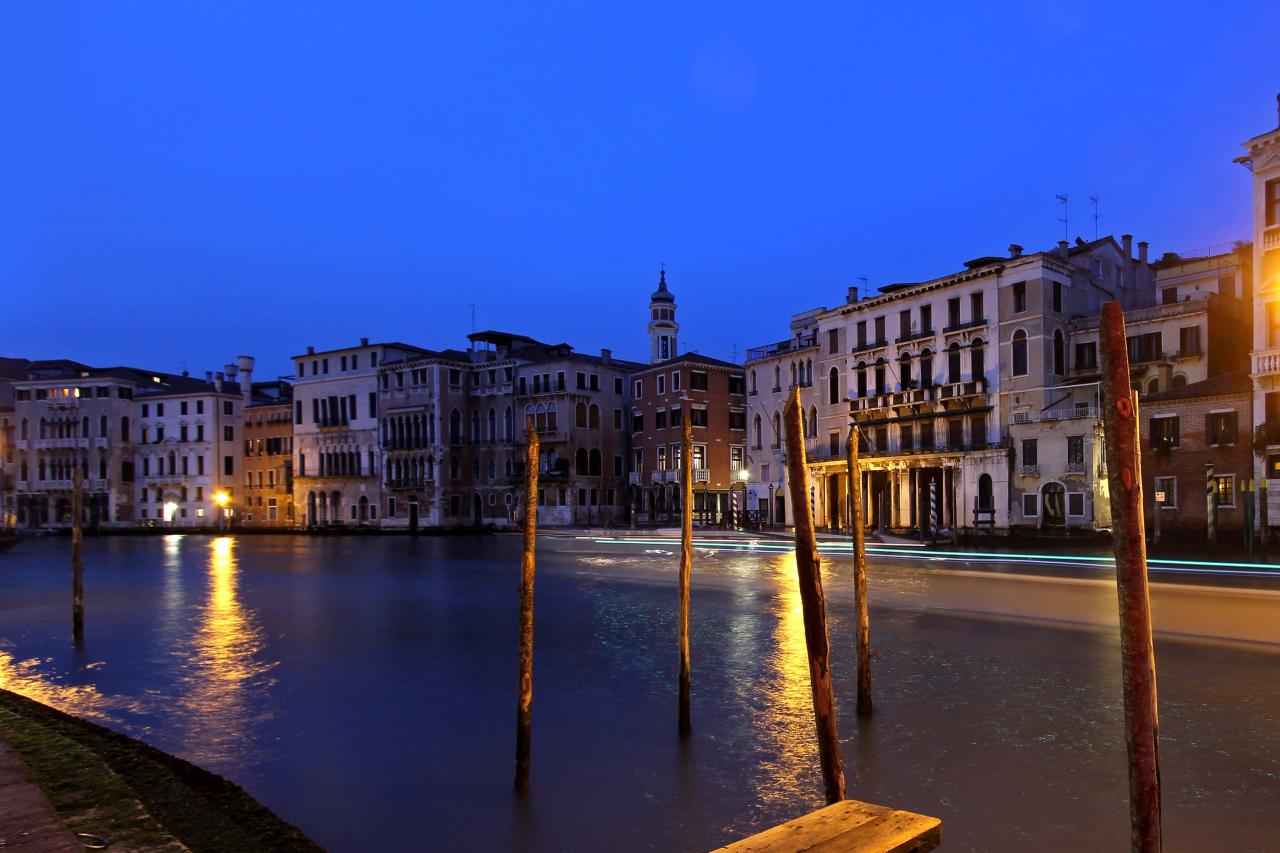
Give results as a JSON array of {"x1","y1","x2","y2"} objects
[{"x1": 1236, "y1": 96, "x2": 1280, "y2": 526}]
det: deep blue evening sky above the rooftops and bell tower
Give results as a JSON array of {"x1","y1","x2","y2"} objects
[{"x1": 0, "y1": 0, "x2": 1280, "y2": 378}]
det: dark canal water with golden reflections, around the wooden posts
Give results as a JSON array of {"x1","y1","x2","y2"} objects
[{"x1": 0, "y1": 535, "x2": 1280, "y2": 850}]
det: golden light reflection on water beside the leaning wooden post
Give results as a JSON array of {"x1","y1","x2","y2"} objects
[{"x1": 756, "y1": 553, "x2": 818, "y2": 806}]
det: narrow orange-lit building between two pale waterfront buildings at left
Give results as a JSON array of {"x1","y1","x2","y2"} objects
[{"x1": 237, "y1": 379, "x2": 296, "y2": 528}]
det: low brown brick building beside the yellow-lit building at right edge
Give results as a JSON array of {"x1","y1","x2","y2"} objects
[{"x1": 1139, "y1": 370, "x2": 1253, "y2": 540}]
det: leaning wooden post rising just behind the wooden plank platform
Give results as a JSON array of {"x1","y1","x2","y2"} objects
[{"x1": 783, "y1": 387, "x2": 845, "y2": 803}]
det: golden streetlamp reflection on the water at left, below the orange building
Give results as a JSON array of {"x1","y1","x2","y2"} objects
[{"x1": 178, "y1": 537, "x2": 274, "y2": 770}]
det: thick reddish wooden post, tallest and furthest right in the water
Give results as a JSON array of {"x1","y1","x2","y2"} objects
[{"x1": 1101, "y1": 302, "x2": 1161, "y2": 853}]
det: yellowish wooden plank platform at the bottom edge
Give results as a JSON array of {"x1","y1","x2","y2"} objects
[{"x1": 713, "y1": 799, "x2": 942, "y2": 853}]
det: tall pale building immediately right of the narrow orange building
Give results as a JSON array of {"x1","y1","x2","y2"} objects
[{"x1": 293, "y1": 338, "x2": 425, "y2": 528}]
